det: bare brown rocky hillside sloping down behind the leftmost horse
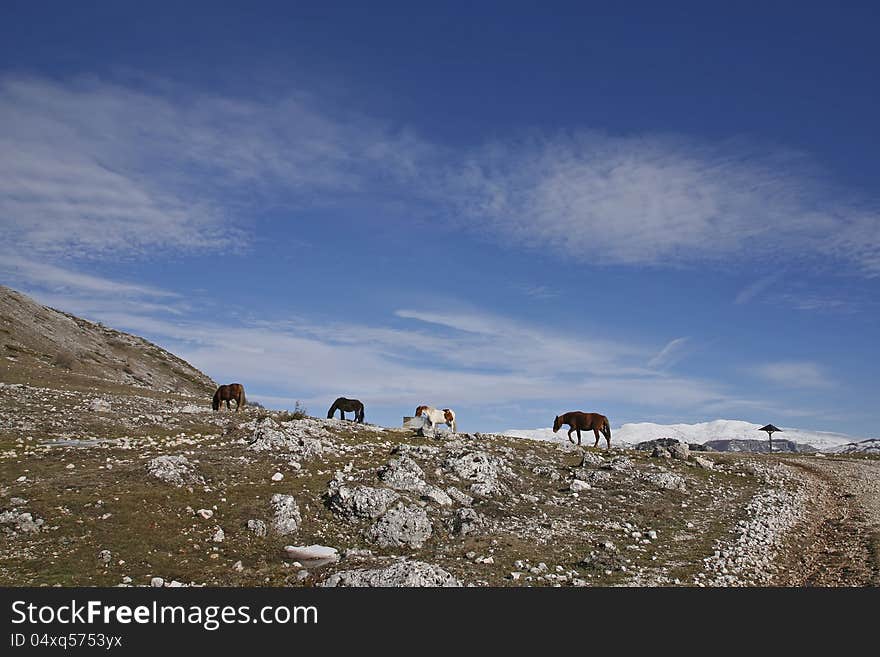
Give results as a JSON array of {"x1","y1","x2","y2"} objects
[{"x1": 0, "y1": 286, "x2": 216, "y2": 397}]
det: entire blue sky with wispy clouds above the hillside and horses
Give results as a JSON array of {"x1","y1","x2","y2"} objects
[{"x1": 0, "y1": 2, "x2": 880, "y2": 436}]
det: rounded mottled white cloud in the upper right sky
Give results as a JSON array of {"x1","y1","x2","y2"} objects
[{"x1": 450, "y1": 132, "x2": 880, "y2": 275}]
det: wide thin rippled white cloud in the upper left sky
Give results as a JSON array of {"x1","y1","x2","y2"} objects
[{"x1": 0, "y1": 78, "x2": 422, "y2": 257}]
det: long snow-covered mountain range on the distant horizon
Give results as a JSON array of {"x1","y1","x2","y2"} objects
[{"x1": 503, "y1": 420, "x2": 862, "y2": 451}]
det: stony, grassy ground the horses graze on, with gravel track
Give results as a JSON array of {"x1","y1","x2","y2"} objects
[{"x1": 0, "y1": 376, "x2": 880, "y2": 586}]
